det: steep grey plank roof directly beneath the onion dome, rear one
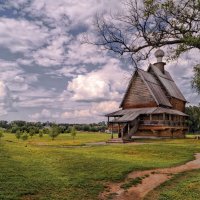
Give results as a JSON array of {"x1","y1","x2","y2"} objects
[{"x1": 147, "y1": 64, "x2": 186, "y2": 102}]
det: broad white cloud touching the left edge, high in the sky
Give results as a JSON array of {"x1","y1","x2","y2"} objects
[{"x1": 0, "y1": 17, "x2": 48, "y2": 52}]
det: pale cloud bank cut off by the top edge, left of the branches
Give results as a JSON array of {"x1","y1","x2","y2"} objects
[{"x1": 25, "y1": 0, "x2": 121, "y2": 25}]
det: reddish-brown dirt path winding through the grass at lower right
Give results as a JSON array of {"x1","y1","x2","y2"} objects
[{"x1": 99, "y1": 153, "x2": 200, "y2": 200}]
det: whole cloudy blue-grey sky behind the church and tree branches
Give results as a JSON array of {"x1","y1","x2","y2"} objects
[{"x1": 0, "y1": 0, "x2": 200, "y2": 123}]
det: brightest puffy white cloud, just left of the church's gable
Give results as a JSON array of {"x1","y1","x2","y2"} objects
[{"x1": 67, "y1": 59, "x2": 130, "y2": 101}]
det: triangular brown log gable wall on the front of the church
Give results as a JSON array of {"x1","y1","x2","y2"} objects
[{"x1": 122, "y1": 74, "x2": 157, "y2": 109}]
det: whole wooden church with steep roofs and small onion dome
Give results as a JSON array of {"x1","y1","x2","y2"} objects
[{"x1": 106, "y1": 49, "x2": 188, "y2": 141}]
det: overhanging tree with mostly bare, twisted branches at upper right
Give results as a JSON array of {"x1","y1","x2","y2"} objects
[{"x1": 84, "y1": 0, "x2": 200, "y2": 64}]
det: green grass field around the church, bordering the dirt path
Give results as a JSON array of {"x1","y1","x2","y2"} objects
[{"x1": 0, "y1": 133, "x2": 200, "y2": 200}]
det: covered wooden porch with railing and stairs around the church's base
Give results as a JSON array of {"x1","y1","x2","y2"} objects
[{"x1": 108, "y1": 113, "x2": 188, "y2": 140}]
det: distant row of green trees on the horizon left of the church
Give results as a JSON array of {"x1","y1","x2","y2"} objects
[{"x1": 0, "y1": 120, "x2": 106, "y2": 136}]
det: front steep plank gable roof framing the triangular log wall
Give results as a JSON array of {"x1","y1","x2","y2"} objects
[{"x1": 120, "y1": 69, "x2": 172, "y2": 107}]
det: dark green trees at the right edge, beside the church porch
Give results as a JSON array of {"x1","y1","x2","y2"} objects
[{"x1": 186, "y1": 105, "x2": 200, "y2": 133}]
